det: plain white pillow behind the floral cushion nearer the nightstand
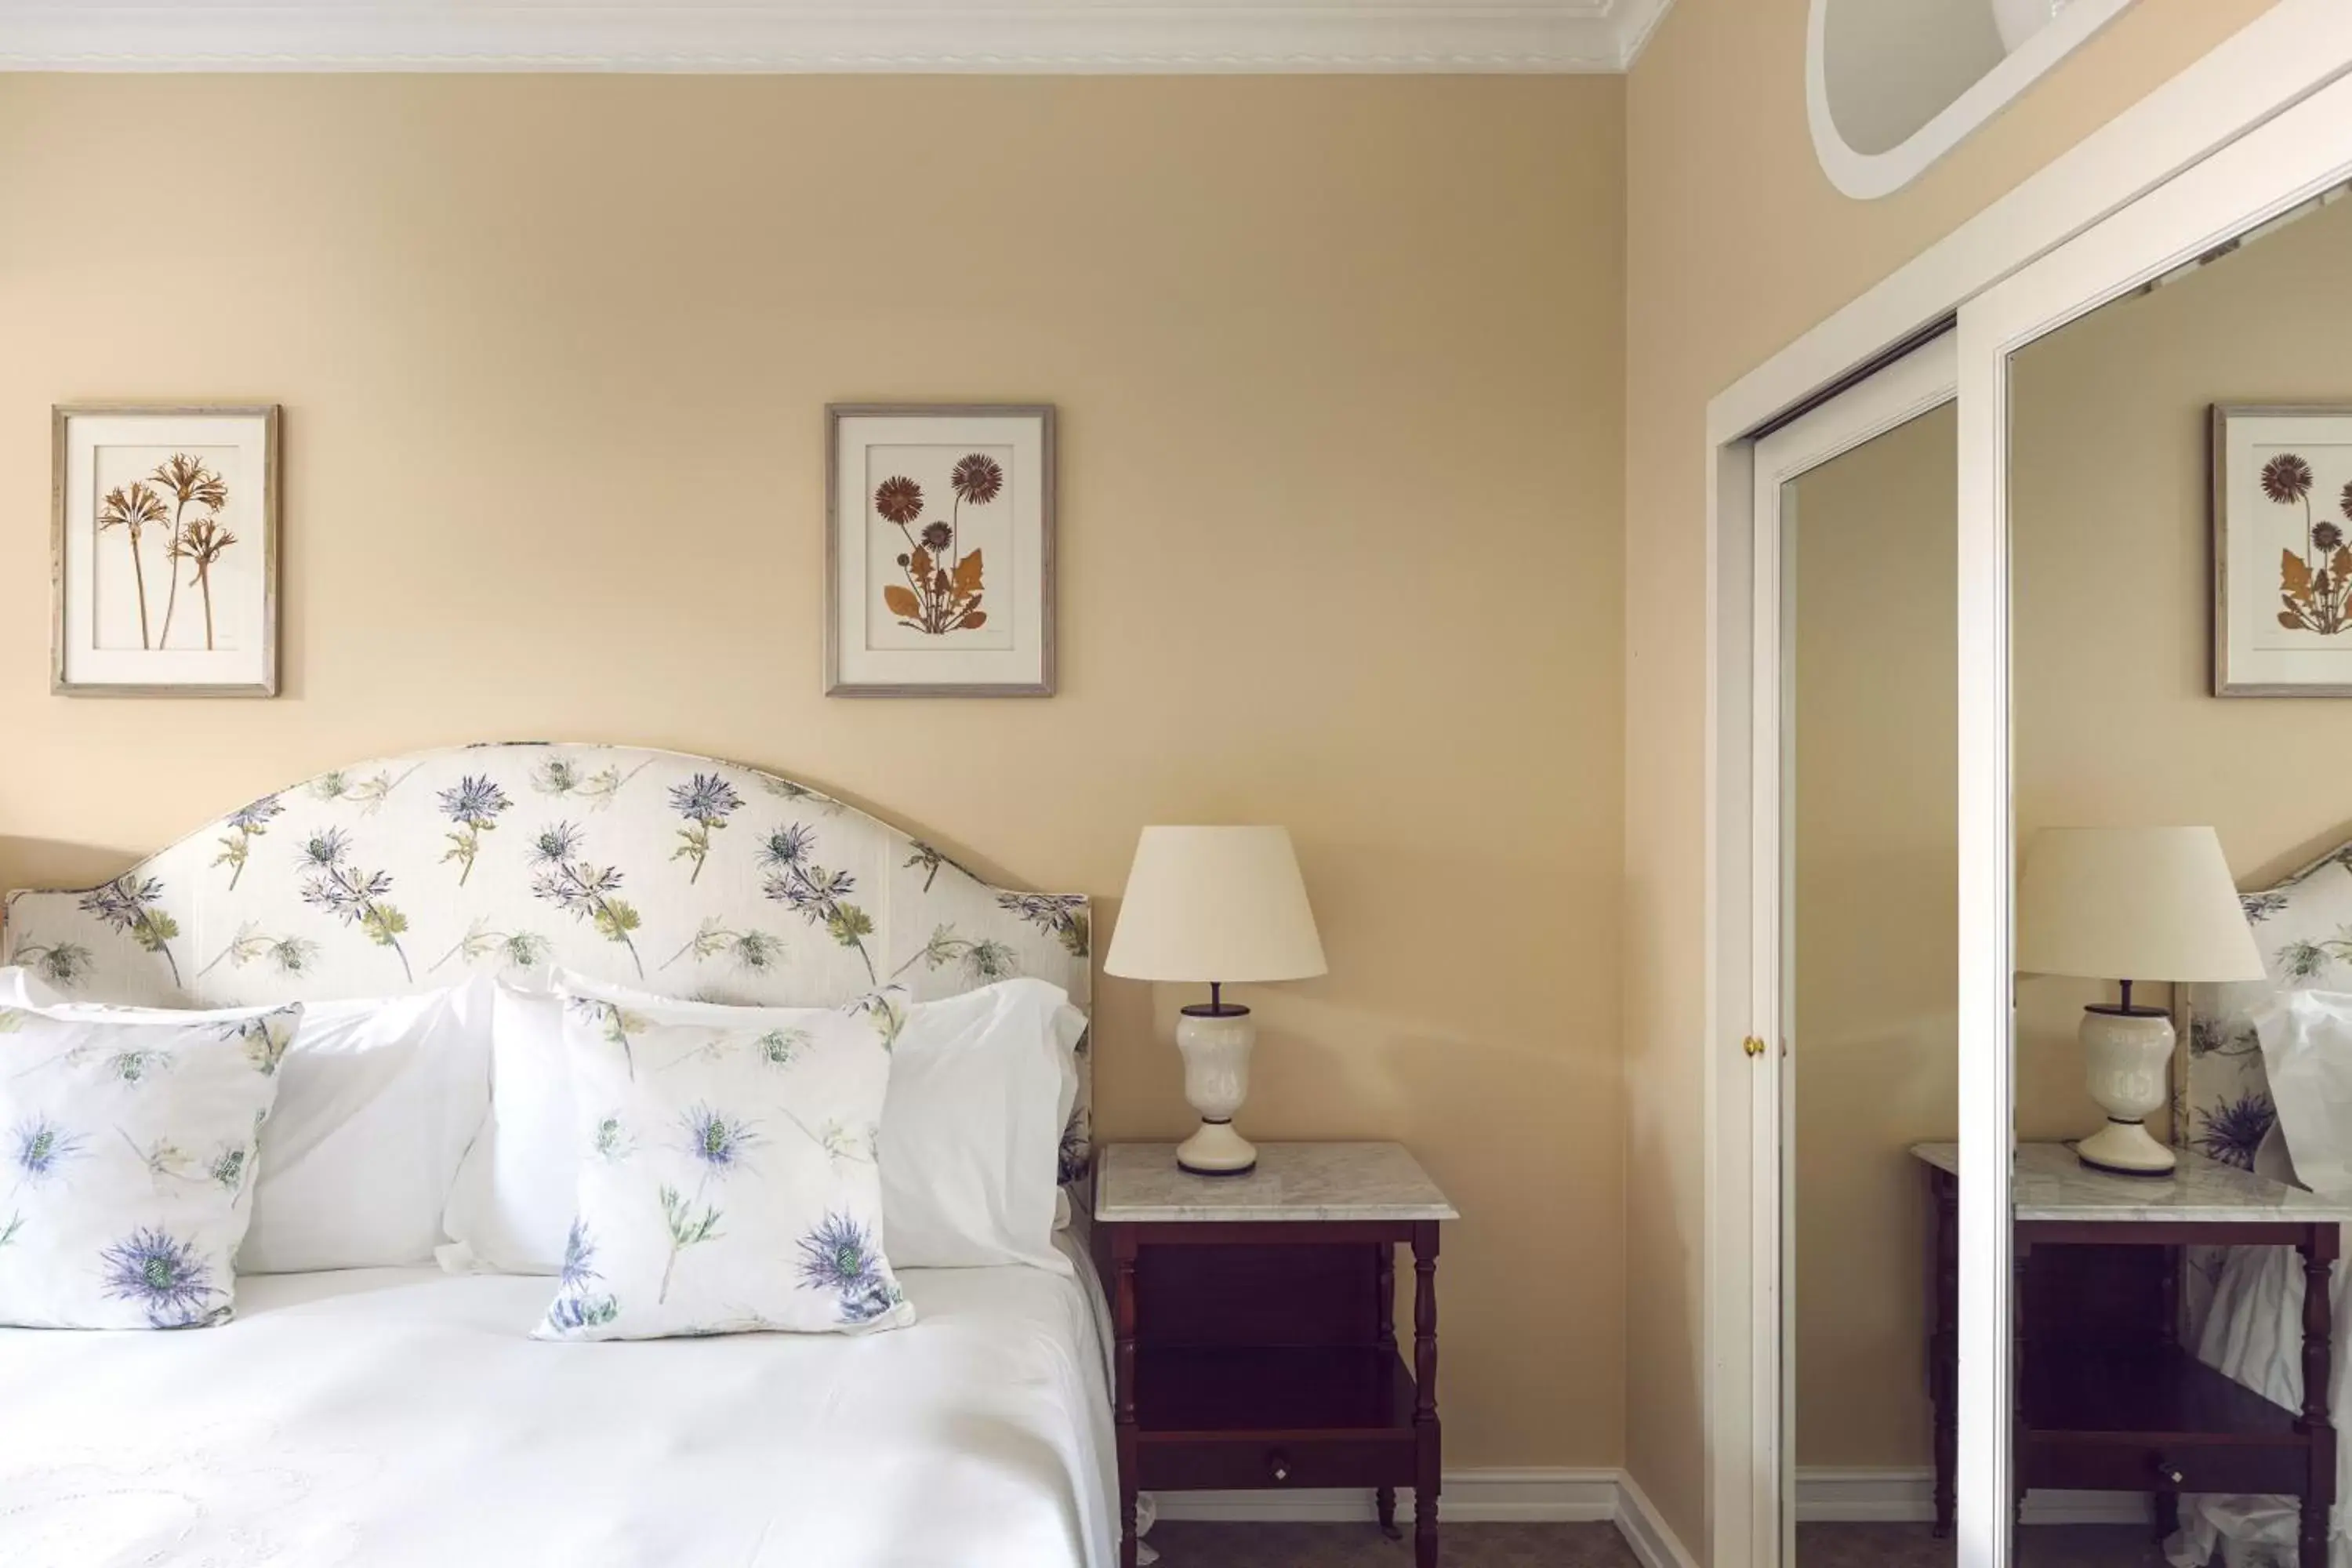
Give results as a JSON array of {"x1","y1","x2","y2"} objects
[{"x1": 442, "y1": 973, "x2": 1087, "y2": 1274}]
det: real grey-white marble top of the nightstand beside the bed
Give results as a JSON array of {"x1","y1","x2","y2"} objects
[{"x1": 1094, "y1": 1142, "x2": 1461, "y2": 1225}]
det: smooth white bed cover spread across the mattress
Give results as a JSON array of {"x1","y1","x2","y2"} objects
[{"x1": 0, "y1": 1246, "x2": 1117, "y2": 1568}]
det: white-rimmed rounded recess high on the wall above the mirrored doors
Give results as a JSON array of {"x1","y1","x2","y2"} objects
[{"x1": 1804, "y1": 0, "x2": 2131, "y2": 200}]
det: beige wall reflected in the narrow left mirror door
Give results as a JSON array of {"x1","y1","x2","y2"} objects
[{"x1": 1790, "y1": 405, "x2": 1959, "y2": 1467}]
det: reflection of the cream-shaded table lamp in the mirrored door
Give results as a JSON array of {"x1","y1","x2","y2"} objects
[{"x1": 2018, "y1": 827, "x2": 2263, "y2": 1175}]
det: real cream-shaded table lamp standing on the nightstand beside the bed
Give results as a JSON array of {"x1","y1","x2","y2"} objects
[{"x1": 1103, "y1": 827, "x2": 1324, "y2": 1175}]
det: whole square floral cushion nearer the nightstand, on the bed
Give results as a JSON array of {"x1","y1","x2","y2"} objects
[{"x1": 534, "y1": 987, "x2": 915, "y2": 1340}]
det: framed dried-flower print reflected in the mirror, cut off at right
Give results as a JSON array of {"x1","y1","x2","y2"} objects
[{"x1": 2213, "y1": 405, "x2": 2352, "y2": 696}]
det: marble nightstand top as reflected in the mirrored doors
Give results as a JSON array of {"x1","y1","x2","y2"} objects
[{"x1": 1912, "y1": 1142, "x2": 2352, "y2": 1225}]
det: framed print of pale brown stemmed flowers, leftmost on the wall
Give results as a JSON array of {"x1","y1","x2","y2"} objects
[{"x1": 49, "y1": 405, "x2": 278, "y2": 696}]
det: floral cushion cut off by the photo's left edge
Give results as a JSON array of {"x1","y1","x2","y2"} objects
[{"x1": 0, "y1": 1004, "x2": 301, "y2": 1328}]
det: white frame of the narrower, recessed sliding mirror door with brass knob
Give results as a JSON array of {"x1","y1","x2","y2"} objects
[{"x1": 1748, "y1": 343, "x2": 1959, "y2": 1561}]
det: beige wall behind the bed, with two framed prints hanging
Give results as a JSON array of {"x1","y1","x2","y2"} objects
[{"x1": 0, "y1": 75, "x2": 1625, "y2": 1465}]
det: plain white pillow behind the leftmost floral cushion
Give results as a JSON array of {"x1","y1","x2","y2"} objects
[{"x1": 0, "y1": 968, "x2": 492, "y2": 1274}]
